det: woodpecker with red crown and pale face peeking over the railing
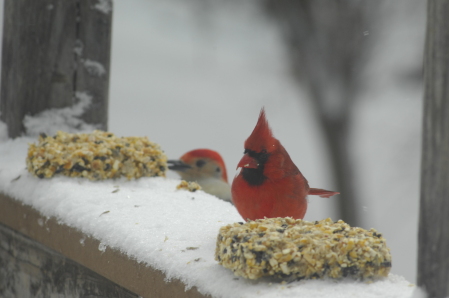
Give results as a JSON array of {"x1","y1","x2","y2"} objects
[{"x1": 167, "y1": 149, "x2": 232, "y2": 203}]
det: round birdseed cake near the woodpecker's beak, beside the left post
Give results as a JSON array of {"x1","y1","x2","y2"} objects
[{"x1": 26, "y1": 130, "x2": 167, "y2": 180}]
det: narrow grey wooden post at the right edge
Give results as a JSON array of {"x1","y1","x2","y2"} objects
[{"x1": 418, "y1": 0, "x2": 449, "y2": 298}]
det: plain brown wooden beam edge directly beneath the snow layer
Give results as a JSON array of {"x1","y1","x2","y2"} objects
[{"x1": 0, "y1": 193, "x2": 206, "y2": 298}]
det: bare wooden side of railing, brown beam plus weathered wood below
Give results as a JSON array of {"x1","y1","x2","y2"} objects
[{"x1": 0, "y1": 194, "x2": 204, "y2": 297}]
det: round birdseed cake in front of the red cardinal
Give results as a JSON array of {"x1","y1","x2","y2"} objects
[{"x1": 215, "y1": 217, "x2": 391, "y2": 280}]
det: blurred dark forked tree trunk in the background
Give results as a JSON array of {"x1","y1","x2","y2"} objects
[{"x1": 265, "y1": 0, "x2": 376, "y2": 226}]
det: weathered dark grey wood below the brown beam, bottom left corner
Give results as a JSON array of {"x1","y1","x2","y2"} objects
[{"x1": 0, "y1": 224, "x2": 138, "y2": 298}]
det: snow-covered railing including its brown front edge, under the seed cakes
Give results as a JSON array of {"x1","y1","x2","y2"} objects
[{"x1": 0, "y1": 137, "x2": 415, "y2": 298}]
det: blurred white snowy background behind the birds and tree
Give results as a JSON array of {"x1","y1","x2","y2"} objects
[{"x1": 0, "y1": 0, "x2": 425, "y2": 297}]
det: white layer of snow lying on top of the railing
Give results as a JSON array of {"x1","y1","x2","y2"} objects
[{"x1": 0, "y1": 137, "x2": 423, "y2": 298}]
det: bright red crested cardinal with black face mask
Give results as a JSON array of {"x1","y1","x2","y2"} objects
[{"x1": 231, "y1": 108, "x2": 339, "y2": 220}]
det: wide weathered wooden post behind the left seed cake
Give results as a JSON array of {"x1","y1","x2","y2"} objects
[{"x1": 0, "y1": 0, "x2": 112, "y2": 138}]
